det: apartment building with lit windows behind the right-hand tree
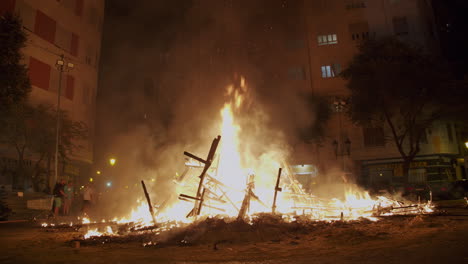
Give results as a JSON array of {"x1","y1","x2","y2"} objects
[{"x1": 298, "y1": 0, "x2": 461, "y2": 190}]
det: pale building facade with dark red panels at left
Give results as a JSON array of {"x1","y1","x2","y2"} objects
[{"x1": 0, "y1": 0, "x2": 104, "y2": 190}]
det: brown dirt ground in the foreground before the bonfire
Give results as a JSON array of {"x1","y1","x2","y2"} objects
[{"x1": 0, "y1": 208, "x2": 468, "y2": 264}]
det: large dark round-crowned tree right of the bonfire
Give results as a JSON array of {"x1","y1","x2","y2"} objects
[{"x1": 342, "y1": 38, "x2": 459, "y2": 182}]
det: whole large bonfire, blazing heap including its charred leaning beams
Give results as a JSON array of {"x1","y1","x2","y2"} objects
[{"x1": 43, "y1": 78, "x2": 432, "y2": 239}]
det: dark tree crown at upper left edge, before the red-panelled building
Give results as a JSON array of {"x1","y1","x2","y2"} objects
[{"x1": 0, "y1": 13, "x2": 31, "y2": 114}]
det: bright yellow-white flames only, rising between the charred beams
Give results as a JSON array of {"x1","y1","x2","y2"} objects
[{"x1": 68, "y1": 74, "x2": 432, "y2": 239}]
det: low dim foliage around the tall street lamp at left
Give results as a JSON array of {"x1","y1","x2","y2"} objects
[{"x1": 0, "y1": 103, "x2": 87, "y2": 190}]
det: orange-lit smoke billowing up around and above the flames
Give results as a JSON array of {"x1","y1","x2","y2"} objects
[{"x1": 95, "y1": 0, "x2": 326, "y2": 219}]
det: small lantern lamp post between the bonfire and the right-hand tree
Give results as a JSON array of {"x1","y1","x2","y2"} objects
[{"x1": 332, "y1": 97, "x2": 351, "y2": 172}]
